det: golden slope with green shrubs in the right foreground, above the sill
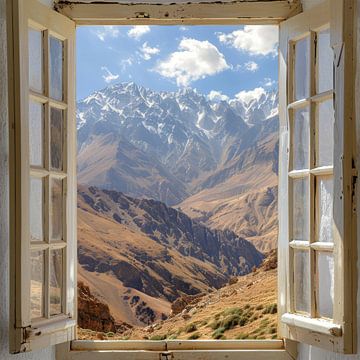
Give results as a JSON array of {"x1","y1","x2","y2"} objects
[{"x1": 78, "y1": 251, "x2": 277, "y2": 340}]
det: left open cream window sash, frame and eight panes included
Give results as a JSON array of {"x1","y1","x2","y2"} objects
[{"x1": 8, "y1": 0, "x2": 76, "y2": 352}]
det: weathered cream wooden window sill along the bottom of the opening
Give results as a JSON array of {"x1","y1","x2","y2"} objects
[{"x1": 57, "y1": 340, "x2": 294, "y2": 360}]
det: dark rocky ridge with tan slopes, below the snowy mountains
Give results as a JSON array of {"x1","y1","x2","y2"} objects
[{"x1": 78, "y1": 186, "x2": 264, "y2": 325}]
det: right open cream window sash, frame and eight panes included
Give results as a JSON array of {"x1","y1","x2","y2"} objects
[{"x1": 279, "y1": 3, "x2": 352, "y2": 352}]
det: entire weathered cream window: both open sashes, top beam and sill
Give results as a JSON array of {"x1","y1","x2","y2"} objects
[{"x1": 8, "y1": 0, "x2": 356, "y2": 360}]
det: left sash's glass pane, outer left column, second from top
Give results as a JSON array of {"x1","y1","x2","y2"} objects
[{"x1": 29, "y1": 100, "x2": 44, "y2": 166}]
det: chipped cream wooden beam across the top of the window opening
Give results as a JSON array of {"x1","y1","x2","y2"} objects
[{"x1": 56, "y1": 0, "x2": 301, "y2": 25}]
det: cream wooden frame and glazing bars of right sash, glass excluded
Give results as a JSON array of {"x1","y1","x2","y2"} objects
[{"x1": 278, "y1": 0, "x2": 356, "y2": 353}]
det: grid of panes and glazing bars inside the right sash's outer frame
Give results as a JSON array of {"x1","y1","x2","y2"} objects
[{"x1": 288, "y1": 27, "x2": 334, "y2": 320}]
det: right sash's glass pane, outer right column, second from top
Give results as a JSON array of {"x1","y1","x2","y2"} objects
[{"x1": 316, "y1": 100, "x2": 335, "y2": 166}]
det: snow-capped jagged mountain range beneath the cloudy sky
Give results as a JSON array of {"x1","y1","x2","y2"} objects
[{"x1": 77, "y1": 83, "x2": 277, "y2": 205}]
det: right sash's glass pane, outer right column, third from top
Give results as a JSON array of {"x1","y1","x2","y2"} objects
[{"x1": 316, "y1": 176, "x2": 333, "y2": 242}]
